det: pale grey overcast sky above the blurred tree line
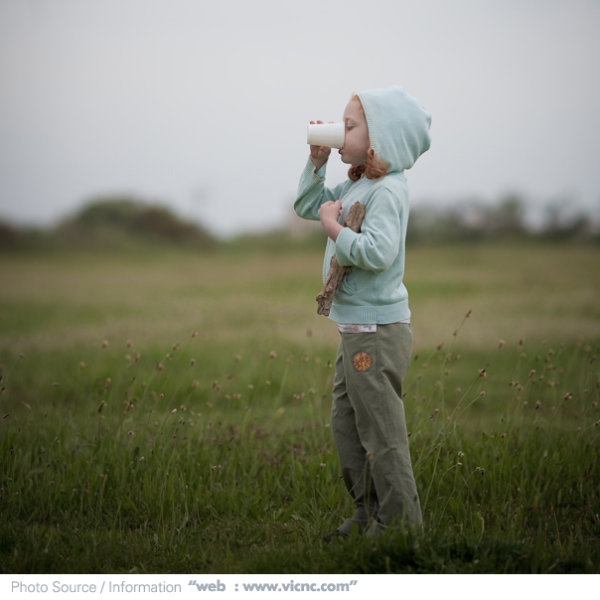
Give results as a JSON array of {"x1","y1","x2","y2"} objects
[{"x1": 0, "y1": 0, "x2": 600, "y2": 235}]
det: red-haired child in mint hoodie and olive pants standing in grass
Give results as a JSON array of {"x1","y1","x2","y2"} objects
[{"x1": 294, "y1": 86, "x2": 431, "y2": 537}]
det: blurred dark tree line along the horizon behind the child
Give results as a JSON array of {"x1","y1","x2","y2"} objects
[{"x1": 0, "y1": 195, "x2": 600, "y2": 250}]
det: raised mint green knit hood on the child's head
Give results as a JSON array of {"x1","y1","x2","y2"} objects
[{"x1": 357, "y1": 86, "x2": 431, "y2": 173}]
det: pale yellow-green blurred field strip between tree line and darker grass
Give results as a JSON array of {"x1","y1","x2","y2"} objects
[{"x1": 0, "y1": 241, "x2": 600, "y2": 351}]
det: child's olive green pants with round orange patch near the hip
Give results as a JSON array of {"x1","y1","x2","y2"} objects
[{"x1": 331, "y1": 323, "x2": 422, "y2": 536}]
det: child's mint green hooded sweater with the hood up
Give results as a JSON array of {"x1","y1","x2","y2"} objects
[{"x1": 294, "y1": 86, "x2": 431, "y2": 324}]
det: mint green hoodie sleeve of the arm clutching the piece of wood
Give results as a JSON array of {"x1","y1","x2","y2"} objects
[{"x1": 336, "y1": 188, "x2": 408, "y2": 272}]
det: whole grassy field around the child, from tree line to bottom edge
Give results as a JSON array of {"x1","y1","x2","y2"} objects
[{"x1": 0, "y1": 242, "x2": 600, "y2": 573}]
